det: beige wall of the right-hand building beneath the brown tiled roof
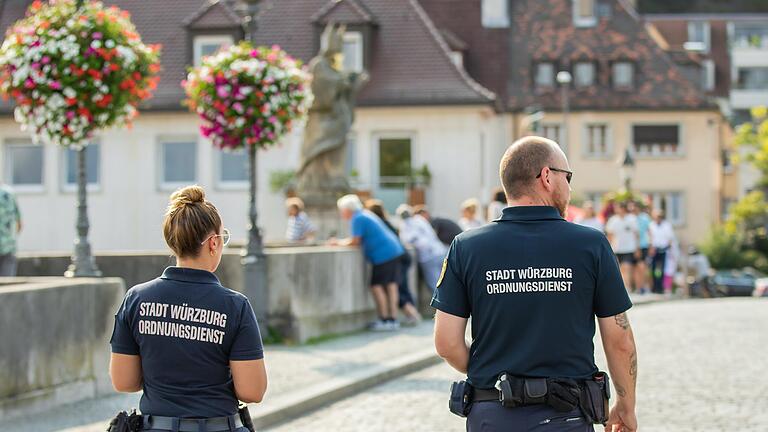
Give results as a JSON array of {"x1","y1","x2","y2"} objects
[{"x1": 515, "y1": 111, "x2": 726, "y2": 242}]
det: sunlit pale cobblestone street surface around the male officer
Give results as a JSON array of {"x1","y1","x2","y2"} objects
[{"x1": 270, "y1": 299, "x2": 768, "y2": 432}]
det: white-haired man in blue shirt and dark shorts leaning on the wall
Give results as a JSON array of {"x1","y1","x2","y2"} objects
[{"x1": 329, "y1": 195, "x2": 412, "y2": 331}]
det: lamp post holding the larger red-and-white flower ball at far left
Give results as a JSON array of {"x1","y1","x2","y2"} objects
[{"x1": 64, "y1": 0, "x2": 101, "y2": 277}]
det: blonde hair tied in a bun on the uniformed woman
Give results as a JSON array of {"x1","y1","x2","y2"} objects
[{"x1": 163, "y1": 185, "x2": 221, "y2": 258}]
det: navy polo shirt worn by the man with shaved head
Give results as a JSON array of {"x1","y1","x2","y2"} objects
[{"x1": 432, "y1": 207, "x2": 632, "y2": 388}]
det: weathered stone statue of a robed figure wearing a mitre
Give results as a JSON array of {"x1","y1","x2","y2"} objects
[{"x1": 296, "y1": 23, "x2": 368, "y2": 206}]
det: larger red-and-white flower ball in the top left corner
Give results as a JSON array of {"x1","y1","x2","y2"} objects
[{"x1": 0, "y1": 0, "x2": 160, "y2": 148}]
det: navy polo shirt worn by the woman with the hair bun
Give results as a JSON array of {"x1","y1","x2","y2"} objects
[{"x1": 111, "y1": 267, "x2": 264, "y2": 418}]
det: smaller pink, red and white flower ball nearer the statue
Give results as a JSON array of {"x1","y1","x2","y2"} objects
[{"x1": 182, "y1": 42, "x2": 311, "y2": 150}]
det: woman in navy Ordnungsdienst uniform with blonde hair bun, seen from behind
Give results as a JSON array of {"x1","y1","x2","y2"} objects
[{"x1": 110, "y1": 186, "x2": 267, "y2": 432}]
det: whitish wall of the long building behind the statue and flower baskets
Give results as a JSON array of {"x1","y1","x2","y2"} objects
[{"x1": 0, "y1": 107, "x2": 510, "y2": 252}]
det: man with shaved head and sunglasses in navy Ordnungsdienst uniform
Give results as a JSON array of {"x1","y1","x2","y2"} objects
[{"x1": 432, "y1": 137, "x2": 637, "y2": 431}]
